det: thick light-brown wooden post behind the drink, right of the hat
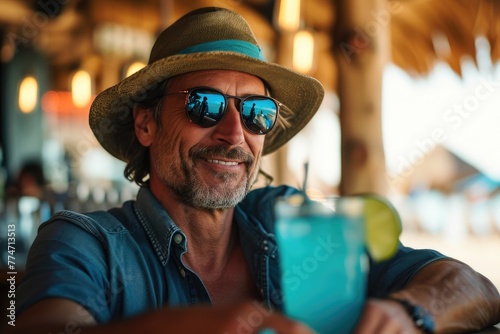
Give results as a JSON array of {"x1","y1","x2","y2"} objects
[{"x1": 333, "y1": 0, "x2": 391, "y2": 195}]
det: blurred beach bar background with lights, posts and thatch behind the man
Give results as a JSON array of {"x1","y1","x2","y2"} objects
[{"x1": 0, "y1": 0, "x2": 500, "y2": 287}]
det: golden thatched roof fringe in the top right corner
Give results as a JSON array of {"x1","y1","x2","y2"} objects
[{"x1": 391, "y1": 0, "x2": 500, "y2": 74}]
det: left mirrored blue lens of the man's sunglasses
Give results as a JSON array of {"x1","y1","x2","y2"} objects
[{"x1": 186, "y1": 89, "x2": 226, "y2": 128}]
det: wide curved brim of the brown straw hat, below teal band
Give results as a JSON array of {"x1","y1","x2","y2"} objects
[{"x1": 89, "y1": 51, "x2": 324, "y2": 162}]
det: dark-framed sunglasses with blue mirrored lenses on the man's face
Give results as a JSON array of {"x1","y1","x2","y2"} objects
[{"x1": 165, "y1": 87, "x2": 282, "y2": 135}]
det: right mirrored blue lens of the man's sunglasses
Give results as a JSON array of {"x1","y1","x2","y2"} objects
[{"x1": 241, "y1": 96, "x2": 278, "y2": 134}]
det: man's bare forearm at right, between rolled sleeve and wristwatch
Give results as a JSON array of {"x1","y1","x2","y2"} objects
[{"x1": 392, "y1": 259, "x2": 500, "y2": 333}]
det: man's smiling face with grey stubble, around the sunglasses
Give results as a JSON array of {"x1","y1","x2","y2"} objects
[{"x1": 150, "y1": 70, "x2": 265, "y2": 210}]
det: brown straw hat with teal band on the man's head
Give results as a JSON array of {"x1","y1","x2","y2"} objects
[{"x1": 89, "y1": 7, "x2": 324, "y2": 162}]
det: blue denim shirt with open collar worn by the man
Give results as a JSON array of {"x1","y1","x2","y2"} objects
[{"x1": 16, "y1": 186, "x2": 443, "y2": 323}]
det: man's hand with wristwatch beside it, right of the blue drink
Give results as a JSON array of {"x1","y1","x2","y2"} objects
[{"x1": 355, "y1": 299, "x2": 419, "y2": 334}]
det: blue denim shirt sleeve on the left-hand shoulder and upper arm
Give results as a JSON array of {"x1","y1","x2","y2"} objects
[{"x1": 16, "y1": 220, "x2": 110, "y2": 322}]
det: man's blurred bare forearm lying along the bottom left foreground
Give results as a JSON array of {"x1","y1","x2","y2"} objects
[{"x1": 9, "y1": 299, "x2": 312, "y2": 334}]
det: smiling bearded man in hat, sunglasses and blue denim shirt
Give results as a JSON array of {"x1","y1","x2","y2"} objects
[{"x1": 16, "y1": 8, "x2": 500, "y2": 334}]
